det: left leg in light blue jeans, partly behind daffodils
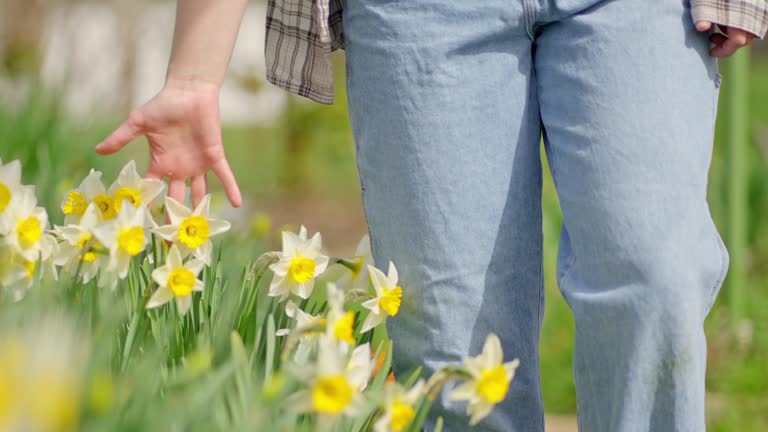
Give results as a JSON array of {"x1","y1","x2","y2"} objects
[{"x1": 344, "y1": 0, "x2": 543, "y2": 432}]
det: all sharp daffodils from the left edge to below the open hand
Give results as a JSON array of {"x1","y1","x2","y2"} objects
[{"x1": 0, "y1": 161, "x2": 230, "y2": 314}]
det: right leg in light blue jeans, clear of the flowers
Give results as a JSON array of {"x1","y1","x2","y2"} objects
[{"x1": 534, "y1": 0, "x2": 728, "y2": 432}]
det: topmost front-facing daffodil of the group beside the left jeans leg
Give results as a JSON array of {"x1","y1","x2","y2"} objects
[{"x1": 269, "y1": 226, "x2": 328, "y2": 300}]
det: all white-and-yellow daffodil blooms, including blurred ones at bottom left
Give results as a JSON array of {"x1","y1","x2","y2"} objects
[{"x1": 0, "y1": 161, "x2": 518, "y2": 432}]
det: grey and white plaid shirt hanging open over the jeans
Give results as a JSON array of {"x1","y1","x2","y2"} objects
[{"x1": 265, "y1": 0, "x2": 768, "y2": 104}]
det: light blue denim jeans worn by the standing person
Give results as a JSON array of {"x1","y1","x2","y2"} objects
[{"x1": 344, "y1": 0, "x2": 728, "y2": 432}]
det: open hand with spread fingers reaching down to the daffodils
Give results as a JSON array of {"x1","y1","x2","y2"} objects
[{"x1": 96, "y1": 82, "x2": 242, "y2": 207}]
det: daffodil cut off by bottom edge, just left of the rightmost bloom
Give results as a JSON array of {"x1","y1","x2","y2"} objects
[{"x1": 373, "y1": 380, "x2": 424, "y2": 432}]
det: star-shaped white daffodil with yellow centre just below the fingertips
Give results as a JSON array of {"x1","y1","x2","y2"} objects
[{"x1": 152, "y1": 195, "x2": 231, "y2": 265}]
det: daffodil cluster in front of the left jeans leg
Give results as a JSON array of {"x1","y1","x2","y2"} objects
[{"x1": 269, "y1": 230, "x2": 519, "y2": 432}]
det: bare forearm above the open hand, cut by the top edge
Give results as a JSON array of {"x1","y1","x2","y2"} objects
[{"x1": 166, "y1": 0, "x2": 248, "y2": 87}]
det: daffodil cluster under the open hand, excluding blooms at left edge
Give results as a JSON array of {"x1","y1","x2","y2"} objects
[{"x1": 55, "y1": 161, "x2": 230, "y2": 314}]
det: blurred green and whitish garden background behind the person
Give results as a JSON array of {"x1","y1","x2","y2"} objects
[{"x1": 0, "y1": 0, "x2": 768, "y2": 431}]
